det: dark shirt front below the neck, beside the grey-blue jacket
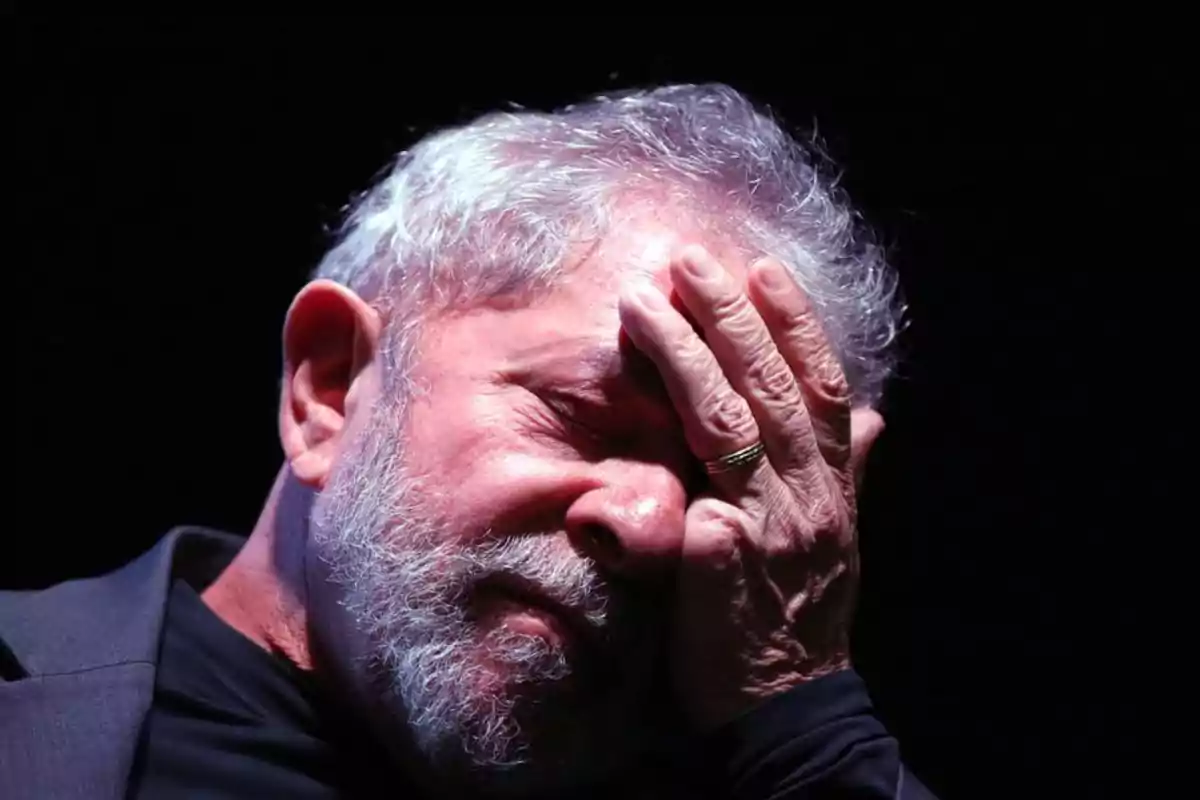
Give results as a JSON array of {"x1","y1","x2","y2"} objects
[{"x1": 130, "y1": 579, "x2": 400, "y2": 800}]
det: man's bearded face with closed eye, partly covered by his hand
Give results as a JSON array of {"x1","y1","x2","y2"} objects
[{"x1": 312, "y1": 223, "x2": 739, "y2": 790}]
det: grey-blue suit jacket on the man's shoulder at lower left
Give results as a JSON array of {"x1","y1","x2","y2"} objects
[{"x1": 0, "y1": 528, "x2": 242, "y2": 800}]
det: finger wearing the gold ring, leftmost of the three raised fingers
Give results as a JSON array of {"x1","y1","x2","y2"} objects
[{"x1": 618, "y1": 278, "x2": 770, "y2": 497}]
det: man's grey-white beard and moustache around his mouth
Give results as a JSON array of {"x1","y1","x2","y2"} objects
[{"x1": 311, "y1": 388, "x2": 670, "y2": 794}]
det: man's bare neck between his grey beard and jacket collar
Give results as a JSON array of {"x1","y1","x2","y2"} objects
[{"x1": 200, "y1": 465, "x2": 312, "y2": 670}]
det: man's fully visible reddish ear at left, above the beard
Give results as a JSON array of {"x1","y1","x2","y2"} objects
[{"x1": 280, "y1": 279, "x2": 380, "y2": 489}]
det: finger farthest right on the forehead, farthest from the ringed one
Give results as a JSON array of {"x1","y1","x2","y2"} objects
[{"x1": 749, "y1": 258, "x2": 851, "y2": 474}]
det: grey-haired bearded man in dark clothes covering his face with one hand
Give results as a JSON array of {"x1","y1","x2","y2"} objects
[{"x1": 0, "y1": 86, "x2": 928, "y2": 798}]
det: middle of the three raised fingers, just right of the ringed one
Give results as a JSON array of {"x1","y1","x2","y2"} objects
[{"x1": 671, "y1": 246, "x2": 826, "y2": 482}]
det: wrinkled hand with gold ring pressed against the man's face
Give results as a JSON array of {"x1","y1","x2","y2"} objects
[{"x1": 620, "y1": 246, "x2": 883, "y2": 728}]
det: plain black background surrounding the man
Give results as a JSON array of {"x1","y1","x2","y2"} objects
[{"x1": 11, "y1": 11, "x2": 1196, "y2": 796}]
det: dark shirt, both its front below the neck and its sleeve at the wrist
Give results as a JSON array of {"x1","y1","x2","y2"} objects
[{"x1": 128, "y1": 579, "x2": 931, "y2": 800}]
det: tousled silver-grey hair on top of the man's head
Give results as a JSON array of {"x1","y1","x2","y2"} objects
[{"x1": 314, "y1": 84, "x2": 904, "y2": 404}]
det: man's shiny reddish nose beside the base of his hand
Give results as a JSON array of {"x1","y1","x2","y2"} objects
[{"x1": 565, "y1": 462, "x2": 686, "y2": 577}]
